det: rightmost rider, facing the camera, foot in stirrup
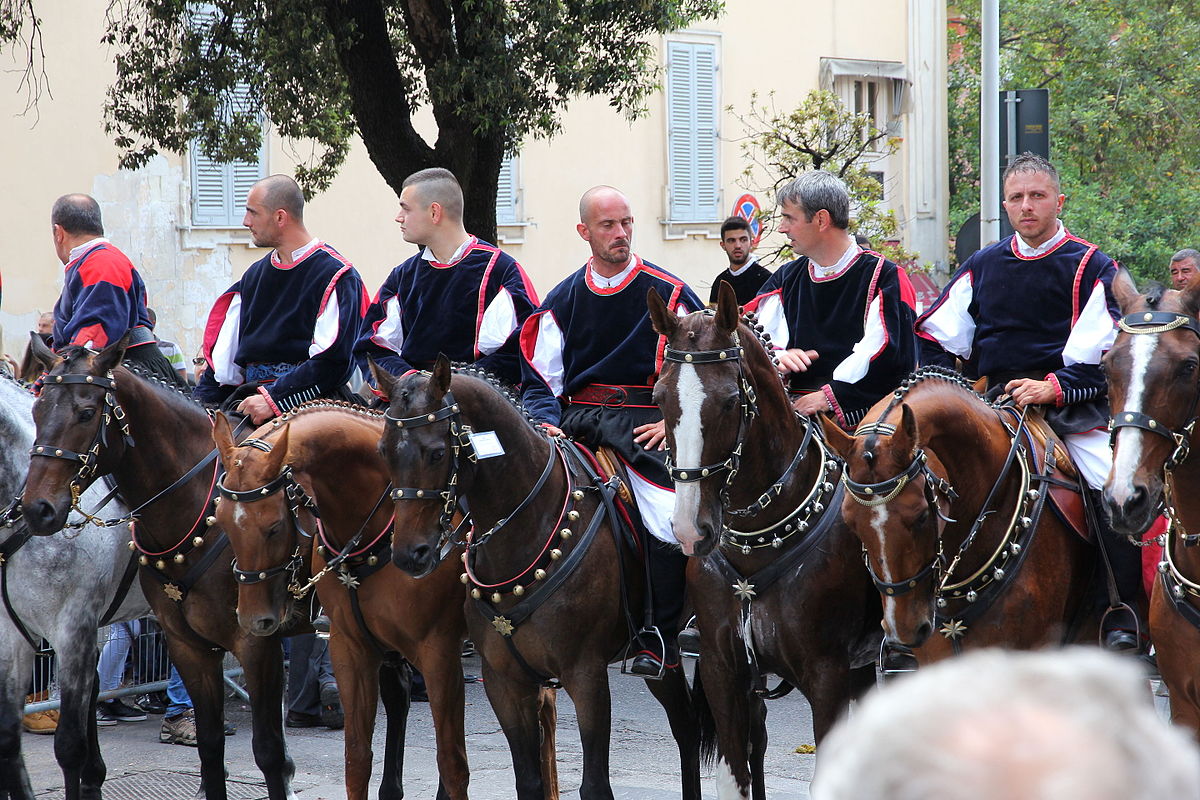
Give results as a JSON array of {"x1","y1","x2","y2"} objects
[{"x1": 917, "y1": 152, "x2": 1141, "y2": 650}]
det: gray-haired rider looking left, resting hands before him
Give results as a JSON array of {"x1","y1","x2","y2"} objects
[{"x1": 746, "y1": 169, "x2": 917, "y2": 428}]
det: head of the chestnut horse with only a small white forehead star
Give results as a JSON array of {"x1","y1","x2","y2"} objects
[{"x1": 212, "y1": 414, "x2": 298, "y2": 636}]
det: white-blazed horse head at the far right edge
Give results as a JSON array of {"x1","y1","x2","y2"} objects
[{"x1": 1102, "y1": 270, "x2": 1200, "y2": 535}]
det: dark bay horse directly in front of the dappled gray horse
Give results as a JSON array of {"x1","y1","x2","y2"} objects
[{"x1": 22, "y1": 341, "x2": 302, "y2": 800}]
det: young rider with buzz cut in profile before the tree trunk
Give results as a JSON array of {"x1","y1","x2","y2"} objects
[{"x1": 354, "y1": 167, "x2": 538, "y2": 384}]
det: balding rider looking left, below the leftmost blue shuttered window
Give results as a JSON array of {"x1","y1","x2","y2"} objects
[{"x1": 194, "y1": 175, "x2": 367, "y2": 425}]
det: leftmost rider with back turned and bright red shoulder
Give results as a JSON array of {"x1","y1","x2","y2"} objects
[{"x1": 50, "y1": 194, "x2": 178, "y2": 383}]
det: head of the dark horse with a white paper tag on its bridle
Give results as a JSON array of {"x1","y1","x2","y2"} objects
[{"x1": 371, "y1": 355, "x2": 461, "y2": 577}]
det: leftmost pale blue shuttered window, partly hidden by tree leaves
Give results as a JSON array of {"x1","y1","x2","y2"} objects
[{"x1": 188, "y1": 4, "x2": 266, "y2": 228}]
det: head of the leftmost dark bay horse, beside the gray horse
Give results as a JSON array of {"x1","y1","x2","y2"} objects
[{"x1": 20, "y1": 337, "x2": 128, "y2": 535}]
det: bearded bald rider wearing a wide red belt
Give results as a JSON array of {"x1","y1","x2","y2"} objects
[{"x1": 521, "y1": 186, "x2": 703, "y2": 676}]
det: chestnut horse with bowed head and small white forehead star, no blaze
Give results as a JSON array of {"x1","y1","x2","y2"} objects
[{"x1": 212, "y1": 401, "x2": 469, "y2": 800}]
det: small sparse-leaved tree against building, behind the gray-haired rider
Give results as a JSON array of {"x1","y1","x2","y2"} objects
[{"x1": 728, "y1": 90, "x2": 913, "y2": 267}]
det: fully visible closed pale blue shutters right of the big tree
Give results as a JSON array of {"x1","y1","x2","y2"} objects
[{"x1": 666, "y1": 41, "x2": 720, "y2": 222}]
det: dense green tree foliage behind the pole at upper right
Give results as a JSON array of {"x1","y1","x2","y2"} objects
[{"x1": 949, "y1": 0, "x2": 1200, "y2": 279}]
